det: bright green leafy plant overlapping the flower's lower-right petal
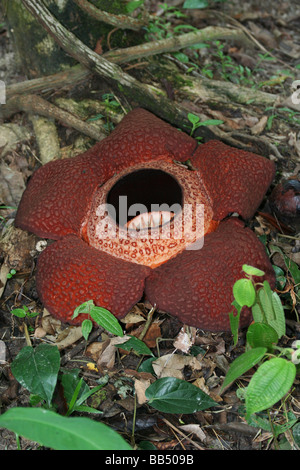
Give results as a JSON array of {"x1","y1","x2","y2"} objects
[{"x1": 223, "y1": 265, "x2": 299, "y2": 422}]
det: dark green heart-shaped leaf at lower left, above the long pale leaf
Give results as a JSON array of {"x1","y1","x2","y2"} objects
[{"x1": 11, "y1": 343, "x2": 60, "y2": 406}]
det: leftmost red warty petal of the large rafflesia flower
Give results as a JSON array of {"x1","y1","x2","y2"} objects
[{"x1": 15, "y1": 153, "x2": 107, "y2": 240}]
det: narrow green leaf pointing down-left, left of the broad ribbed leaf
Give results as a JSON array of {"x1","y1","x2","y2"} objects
[{"x1": 222, "y1": 347, "x2": 267, "y2": 389}]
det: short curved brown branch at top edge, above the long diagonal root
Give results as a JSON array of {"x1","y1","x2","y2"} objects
[{"x1": 73, "y1": 0, "x2": 147, "y2": 31}]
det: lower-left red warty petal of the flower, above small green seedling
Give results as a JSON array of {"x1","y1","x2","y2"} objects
[{"x1": 36, "y1": 235, "x2": 151, "y2": 324}]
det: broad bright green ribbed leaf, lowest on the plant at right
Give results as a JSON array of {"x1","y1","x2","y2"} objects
[{"x1": 245, "y1": 357, "x2": 296, "y2": 419}]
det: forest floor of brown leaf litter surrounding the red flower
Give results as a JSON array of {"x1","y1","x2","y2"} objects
[{"x1": 0, "y1": 0, "x2": 300, "y2": 450}]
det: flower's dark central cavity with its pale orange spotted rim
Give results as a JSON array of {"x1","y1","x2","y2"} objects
[{"x1": 82, "y1": 161, "x2": 217, "y2": 268}]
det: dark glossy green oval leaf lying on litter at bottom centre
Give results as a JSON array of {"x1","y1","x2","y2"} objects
[{"x1": 145, "y1": 377, "x2": 218, "y2": 414}]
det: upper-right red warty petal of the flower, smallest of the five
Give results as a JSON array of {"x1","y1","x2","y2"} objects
[{"x1": 191, "y1": 140, "x2": 275, "y2": 220}]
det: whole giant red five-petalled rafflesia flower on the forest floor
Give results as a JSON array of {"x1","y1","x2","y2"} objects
[{"x1": 15, "y1": 108, "x2": 274, "y2": 331}]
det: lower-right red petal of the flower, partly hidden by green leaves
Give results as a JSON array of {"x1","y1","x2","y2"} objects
[{"x1": 146, "y1": 219, "x2": 275, "y2": 331}]
